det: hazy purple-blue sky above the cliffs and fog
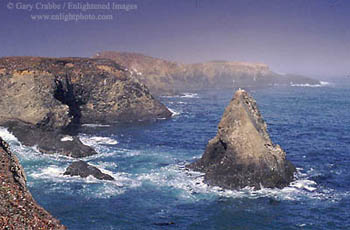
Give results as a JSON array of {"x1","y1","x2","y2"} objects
[{"x1": 0, "y1": 0, "x2": 350, "y2": 76}]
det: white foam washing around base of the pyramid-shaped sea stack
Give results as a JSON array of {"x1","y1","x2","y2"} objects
[{"x1": 138, "y1": 165, "x2": 339, "y2": 200}]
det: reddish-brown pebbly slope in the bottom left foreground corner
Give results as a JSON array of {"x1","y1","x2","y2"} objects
[{"x1": 0, "y1": 138, "x2": 66, "y2": 230}]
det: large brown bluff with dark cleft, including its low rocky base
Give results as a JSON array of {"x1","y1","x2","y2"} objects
[{"x1": 0, "y1": 57, "x2": 171, "y2": 157}]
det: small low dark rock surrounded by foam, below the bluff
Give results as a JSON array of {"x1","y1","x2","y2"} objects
[{"x1": 64, "y1": 161, "x2": 114, "y2": 180}]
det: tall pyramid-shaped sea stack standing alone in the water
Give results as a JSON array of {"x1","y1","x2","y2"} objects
[{"x1": 187, "y1": 90, "x2": 296, "y2": 189}]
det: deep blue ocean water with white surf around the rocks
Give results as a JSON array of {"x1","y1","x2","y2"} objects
[{"x1": 0, "y1": 82, "x2": 350, "y2": 230}]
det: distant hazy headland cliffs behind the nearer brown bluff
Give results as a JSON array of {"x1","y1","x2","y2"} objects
[{"x1": 94, "y1": 51, "x2": 319, "y2": 95}]
